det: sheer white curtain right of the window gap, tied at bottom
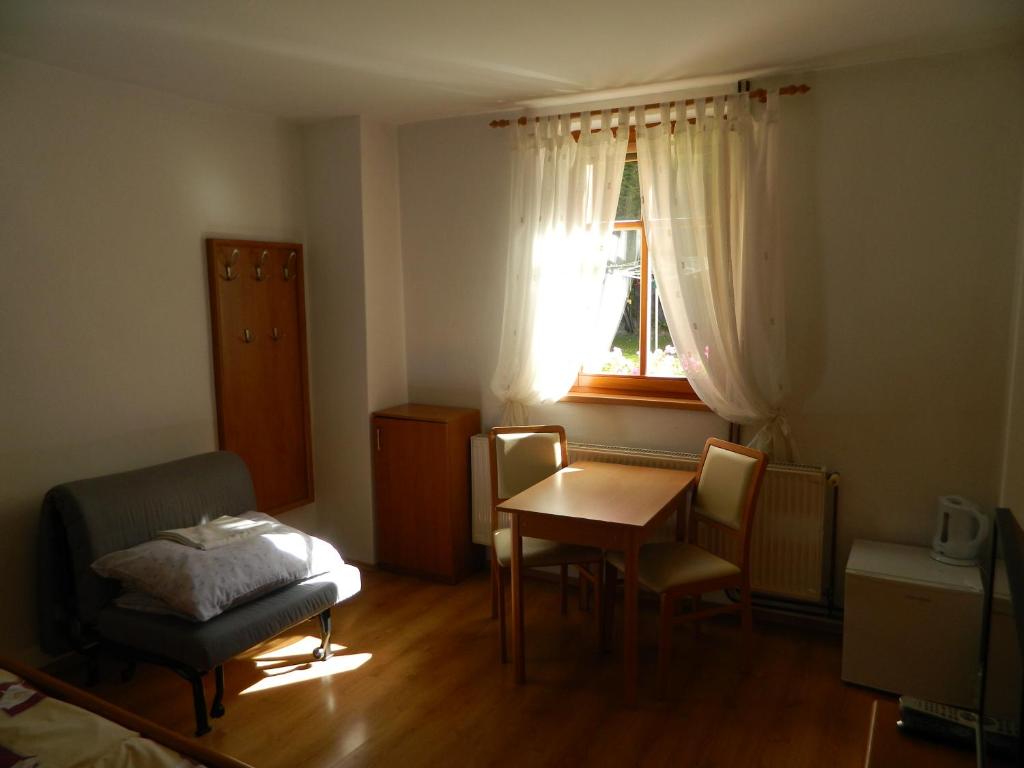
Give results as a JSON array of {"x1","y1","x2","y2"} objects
[{"x1": 637, "y1": 92, "x2": 793, "y2": 461}]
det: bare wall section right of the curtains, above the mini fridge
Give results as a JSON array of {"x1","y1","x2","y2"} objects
[{"x1": 784, "y1": 48, "x2": 1024, "y2": 586}]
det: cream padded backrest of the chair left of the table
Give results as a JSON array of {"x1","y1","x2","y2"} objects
[{"x1": 487, "y1": 424, "x2": 569, "y2": 530}]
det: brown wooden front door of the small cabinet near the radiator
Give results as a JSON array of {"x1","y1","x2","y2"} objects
[{"x1": 374, "y1": 418, "x2": 452, "y2": 578}]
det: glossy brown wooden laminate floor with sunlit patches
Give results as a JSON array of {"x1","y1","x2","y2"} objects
[{"x1": 69, "y1": 570, "x2": 874, "y2": 768}]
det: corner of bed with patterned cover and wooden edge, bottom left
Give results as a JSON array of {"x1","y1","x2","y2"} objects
[{"x1": 0, "y1": 657, "x2": 252, "y2": 768}]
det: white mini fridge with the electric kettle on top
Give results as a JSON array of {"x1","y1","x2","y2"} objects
[{"x1": 843, "y1": 540, "x2": 984, "y2": 709}]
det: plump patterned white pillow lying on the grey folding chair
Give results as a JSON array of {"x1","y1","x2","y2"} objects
[{"x1": 92, "y1": 512, "x2": 344, "y2": 622}]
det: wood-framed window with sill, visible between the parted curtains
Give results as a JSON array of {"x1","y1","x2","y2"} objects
[{"x1": 563, "y1": 153, "x2": 707, "y2": 409}]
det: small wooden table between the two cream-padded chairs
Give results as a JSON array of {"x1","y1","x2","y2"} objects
[{"x1": 498, "y1": 462, "x2": 695, "y2": 706}]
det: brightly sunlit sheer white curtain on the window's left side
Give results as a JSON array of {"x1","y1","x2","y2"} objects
[{"x1": 492, "y1": 110, "x2": 629, "y2": 424}]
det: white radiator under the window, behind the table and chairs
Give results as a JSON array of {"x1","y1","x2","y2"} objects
[{"x1": 471, "y1": 434, "x2": 838, "y2": 602}]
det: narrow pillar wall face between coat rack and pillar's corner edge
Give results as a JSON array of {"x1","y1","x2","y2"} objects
[{"x1": 302, "y1": 118, "x2": 373, "y2": 561}]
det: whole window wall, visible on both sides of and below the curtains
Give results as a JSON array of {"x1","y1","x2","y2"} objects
[{"x1": 399, "y1": 43, "x2": 1024, "y2": 602}]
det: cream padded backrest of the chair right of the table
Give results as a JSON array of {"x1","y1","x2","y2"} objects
[{"x1": 689, "y1": 437, "x2": 768, "y2": 572}]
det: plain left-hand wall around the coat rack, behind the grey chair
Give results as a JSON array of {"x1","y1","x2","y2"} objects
[{"x1": 0, "y1": 57, "x2": 303, "y2": 656}]
